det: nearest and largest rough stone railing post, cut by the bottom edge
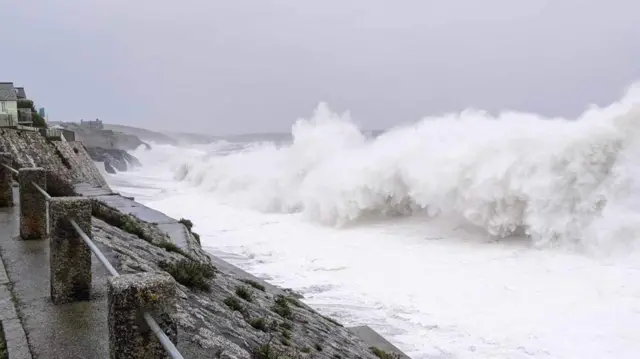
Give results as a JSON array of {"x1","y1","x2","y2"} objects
[{"x1": 108, "y1": 272, "x2": 178, "y2": 359}]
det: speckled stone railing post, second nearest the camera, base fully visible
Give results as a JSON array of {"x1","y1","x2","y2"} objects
[{"x1": 49, "y1": 195, "x2": 91, "y2": 304}]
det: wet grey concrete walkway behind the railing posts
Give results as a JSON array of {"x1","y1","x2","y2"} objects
[{"x1": 0, "y1": 193, "x2": 109, "y2": 359}]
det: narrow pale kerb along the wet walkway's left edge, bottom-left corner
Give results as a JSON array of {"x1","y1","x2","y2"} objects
[{"x1": 0, "y1": 252, "x2": 32, "y2": 359}]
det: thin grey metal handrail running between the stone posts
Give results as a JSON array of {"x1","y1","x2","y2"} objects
[{"x1": 0, "y1": 163, "x2": 184, "y2": 359}]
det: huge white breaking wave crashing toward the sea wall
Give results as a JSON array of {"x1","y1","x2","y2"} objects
[{"x1": 136, "y1": 86, "x2": 640, "y2": 252}]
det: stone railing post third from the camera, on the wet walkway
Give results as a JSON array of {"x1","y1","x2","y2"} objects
[{"x1": 18, "y1": 167, "x2": 47, "y2": 239}]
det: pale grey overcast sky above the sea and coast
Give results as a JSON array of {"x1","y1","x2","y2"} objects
[{"x1": 0, "y1": 0, "x2": 640, "y2": 134}]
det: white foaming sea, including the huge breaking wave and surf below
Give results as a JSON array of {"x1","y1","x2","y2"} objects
[{"x1": 106, "y1": 87, "x2": 640, "y2": 359}]
